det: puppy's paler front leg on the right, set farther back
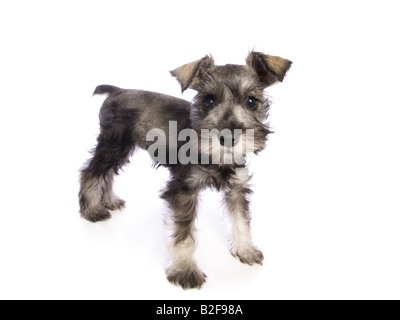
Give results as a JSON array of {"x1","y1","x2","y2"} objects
[{"x1": 224, "y1": 168, "x2": 264, "y2": 265}]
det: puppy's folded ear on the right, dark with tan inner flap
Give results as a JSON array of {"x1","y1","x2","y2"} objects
[{"x1": 246, "y1": 51, "x2": 292, "y2": 88}]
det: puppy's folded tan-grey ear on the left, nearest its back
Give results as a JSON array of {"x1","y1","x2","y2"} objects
[{"x1": 170, "y1": 56, "x2": 214, "y2": 92}]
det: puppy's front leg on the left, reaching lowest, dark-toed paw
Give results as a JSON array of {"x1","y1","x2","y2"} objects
[{"x1": 162, "y1": 180, "x2": 206, "y2": 289}]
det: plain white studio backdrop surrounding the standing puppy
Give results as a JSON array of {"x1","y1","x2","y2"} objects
[{"x1": 0, "y1": 0, "x2": 400, "y2": 299}]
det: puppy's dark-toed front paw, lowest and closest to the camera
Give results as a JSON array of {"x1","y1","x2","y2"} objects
[{"x1": 167, "y1": 266, "x2": 207, "y2": 290}]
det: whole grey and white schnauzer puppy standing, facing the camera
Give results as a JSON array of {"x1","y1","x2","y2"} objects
[{"x1": 79, "y1": 51, "x2": 291, "y2": 289}]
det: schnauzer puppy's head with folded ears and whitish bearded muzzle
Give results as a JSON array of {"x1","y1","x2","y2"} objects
[{"x1": 171, "y1": 52, "x2": 292, "y2": 164}]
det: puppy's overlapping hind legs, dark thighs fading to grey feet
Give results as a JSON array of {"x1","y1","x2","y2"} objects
[{"x1": 79, "y1": 104, "x2": 135, "y2": 222}]
